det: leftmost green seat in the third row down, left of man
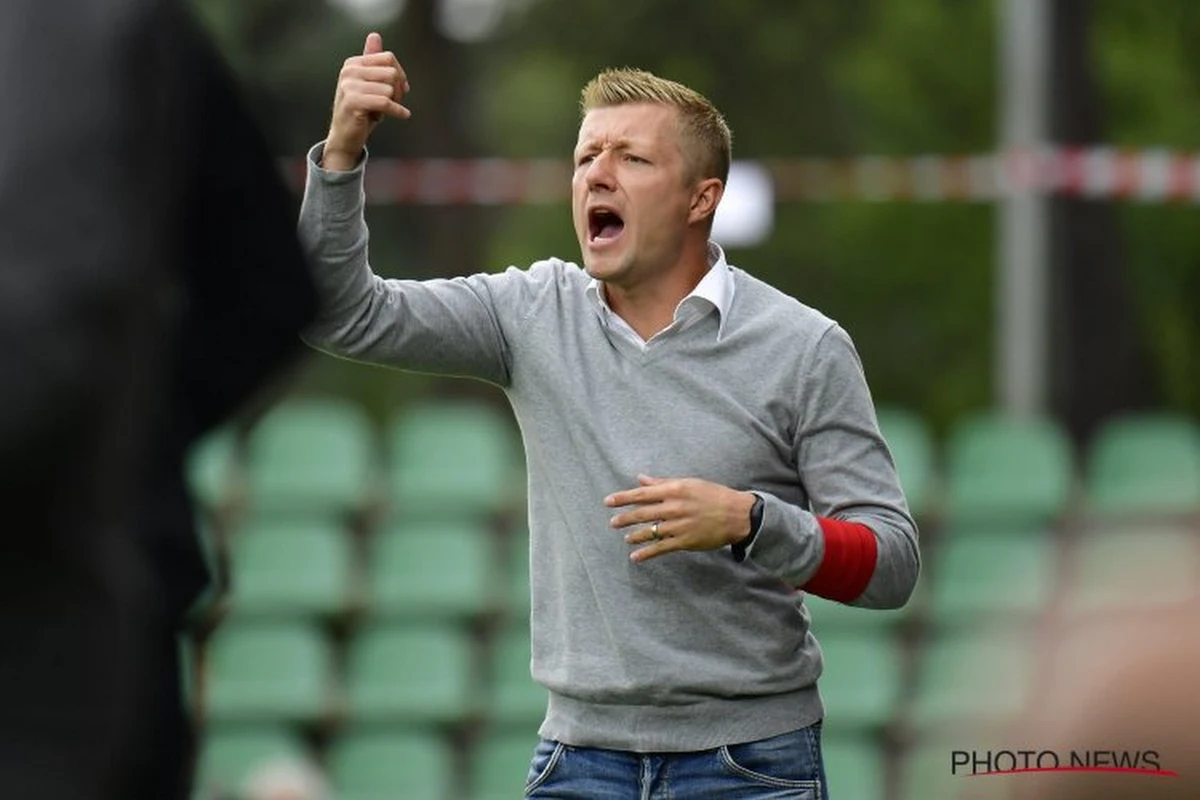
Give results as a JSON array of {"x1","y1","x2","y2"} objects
[{"x1": 206, "y1": 620, "x2": 334, "y2": 722}]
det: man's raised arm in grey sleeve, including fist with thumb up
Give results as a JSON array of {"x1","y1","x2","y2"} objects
[{"x1": 300, "y1": 34, "x2": 518, "y2": 385}]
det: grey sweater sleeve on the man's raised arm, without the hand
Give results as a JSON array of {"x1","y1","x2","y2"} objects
[{"x1": 299, "y1": 144, "x2": 526, "y2": 386}]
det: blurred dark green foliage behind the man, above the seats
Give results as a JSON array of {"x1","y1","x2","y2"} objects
[{"x1": 194, "y1": 0, "x2": 1200, "y2": 428}]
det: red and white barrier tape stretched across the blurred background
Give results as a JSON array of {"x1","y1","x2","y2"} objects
[{"x1": 288, "y1": 146, "x2": 1200, "y2": 205}]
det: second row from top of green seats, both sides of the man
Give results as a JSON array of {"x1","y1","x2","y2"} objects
[{"x1": 211, "y1": 521, "x2": 1200, "y2": 631}]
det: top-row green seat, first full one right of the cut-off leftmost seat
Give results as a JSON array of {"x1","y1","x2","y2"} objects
[{"x1": 246, "y1": 399, "x2": 374, "y2": 516}]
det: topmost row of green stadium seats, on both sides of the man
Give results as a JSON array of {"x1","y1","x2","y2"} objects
[{"x1": 191, "y1": 399, "x2": 1200, "y2": 525}]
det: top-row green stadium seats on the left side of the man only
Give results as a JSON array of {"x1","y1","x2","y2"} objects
[{"x1": 188, "y1": 399, "x2": 524, "y2": 517}]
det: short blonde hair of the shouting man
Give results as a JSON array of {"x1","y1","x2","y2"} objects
[{"x1": 580, "y1": 68, "x2": 733, "y2": 184}]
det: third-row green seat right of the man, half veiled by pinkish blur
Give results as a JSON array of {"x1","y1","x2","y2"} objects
[{"x1": 910, "y1": 628, "x2": 1036, "y2": 729}]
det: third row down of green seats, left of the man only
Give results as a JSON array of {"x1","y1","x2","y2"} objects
[{"x1": 204, "y1": 618, "x2": 546, "y2": 728}]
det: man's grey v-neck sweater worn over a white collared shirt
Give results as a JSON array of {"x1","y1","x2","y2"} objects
[{"x1": 300, "y1": 145, "x2": 919, "y2": 752}]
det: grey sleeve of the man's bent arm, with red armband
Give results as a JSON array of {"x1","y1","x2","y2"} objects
[{"x1": 748, "y1": 325, "x2": 920, "y2": 608}]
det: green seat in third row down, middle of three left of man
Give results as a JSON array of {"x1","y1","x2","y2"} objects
[{"x1": 347, "y1": 624, "x2": 478, "y2": 723}]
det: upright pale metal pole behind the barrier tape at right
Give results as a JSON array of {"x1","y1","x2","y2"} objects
[{"x1": 996, "y1": 0, "x2": 1050, "y2": 415}]
